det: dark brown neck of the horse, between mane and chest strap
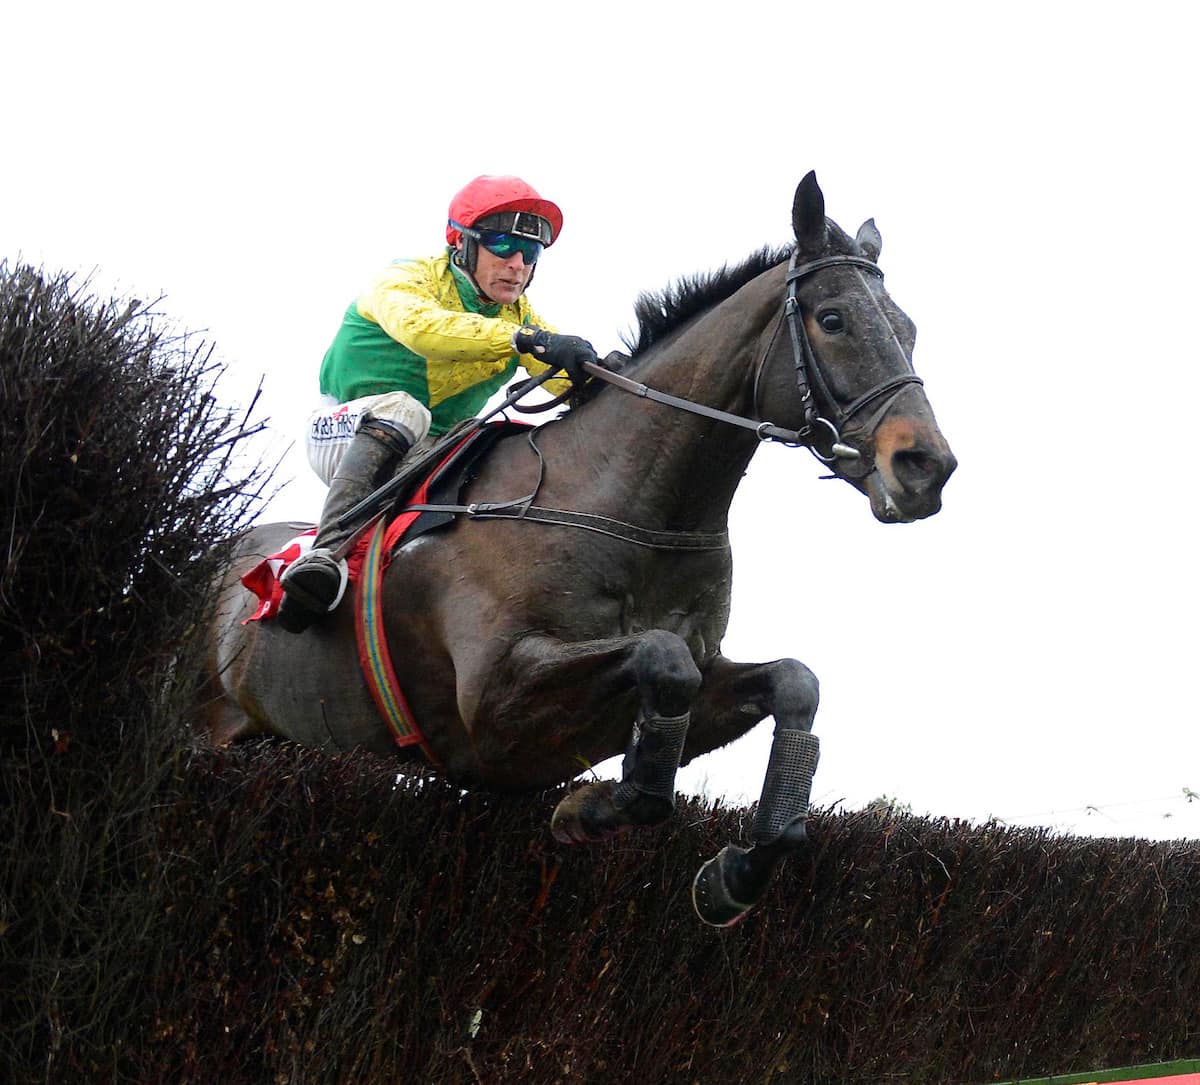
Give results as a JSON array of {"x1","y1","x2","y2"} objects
[{"x1": 559, "y1": 265, "x2": 782, "y2": 530}]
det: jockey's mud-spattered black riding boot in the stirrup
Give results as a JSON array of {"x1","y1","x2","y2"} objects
[{"x1": 277, "y1": 418, "x2": 413, "y2": 633}]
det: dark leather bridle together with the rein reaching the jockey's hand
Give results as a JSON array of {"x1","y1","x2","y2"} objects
[{"x1": 584, "y1": 252, "x2": 924, "y2": 478}]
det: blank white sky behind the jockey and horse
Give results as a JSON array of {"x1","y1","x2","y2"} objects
[{"x1": 0, "y1": 0, "x2": 1200, "y2": 837}]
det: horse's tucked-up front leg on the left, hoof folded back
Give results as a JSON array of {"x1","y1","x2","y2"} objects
[{"x1": 475, "y1": 629, "x2": 701, "y2": 844}]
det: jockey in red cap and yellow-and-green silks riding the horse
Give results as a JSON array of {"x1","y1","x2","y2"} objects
[{"x1": 278, "y1": 176, "x2": 596, "y2": 633}]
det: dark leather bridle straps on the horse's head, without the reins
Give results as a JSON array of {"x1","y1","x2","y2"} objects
[{"x1": 754, "y1": 252, "x2": 924, "y2": 474}]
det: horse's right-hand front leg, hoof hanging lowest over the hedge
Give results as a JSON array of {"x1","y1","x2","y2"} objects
[{"x1": 684, "y1": 657, "x2": 820, "y2": 927}]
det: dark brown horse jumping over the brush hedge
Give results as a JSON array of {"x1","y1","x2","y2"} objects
[{"x1": 204, "y1": 173, "x2": 955, "y2": 927}]
